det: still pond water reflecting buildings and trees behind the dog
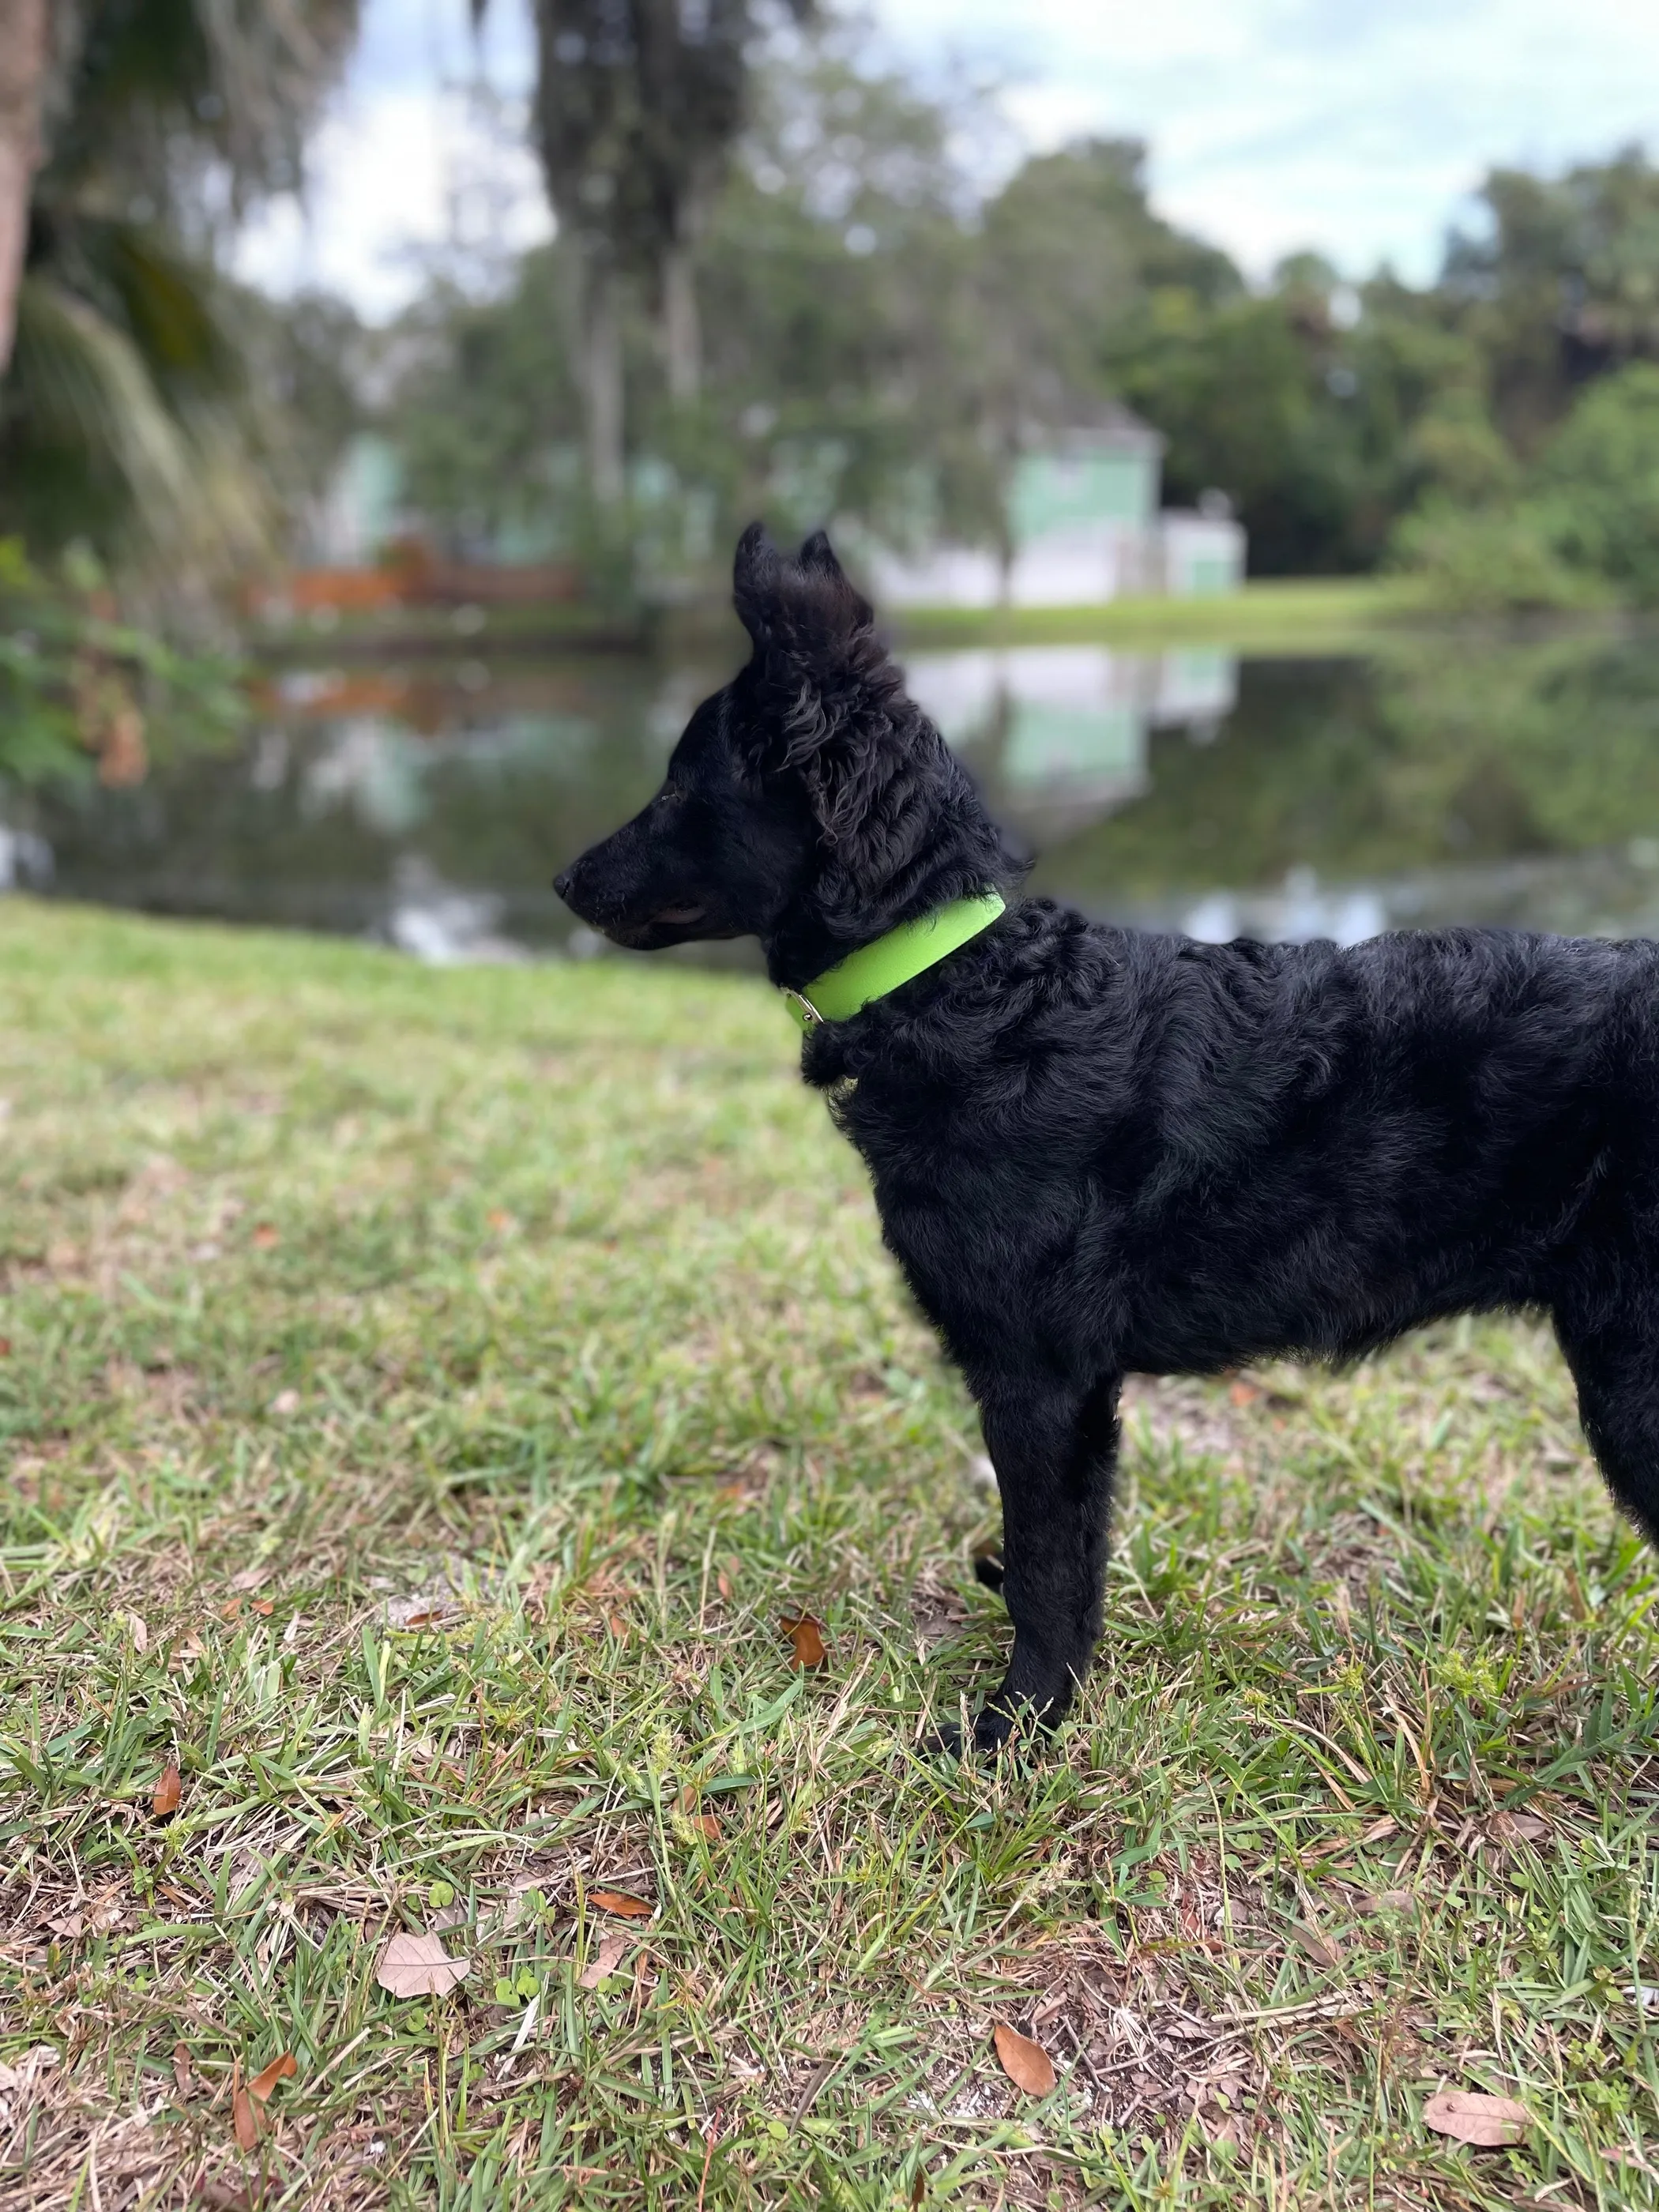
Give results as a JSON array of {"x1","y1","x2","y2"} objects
[{"x1": 0, "y1": 637, "x2": 1659, "y2": 960}]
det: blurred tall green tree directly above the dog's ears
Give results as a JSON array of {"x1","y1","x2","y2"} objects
[{"x1": 694, "y1": 36, "x2": 998, "y2": 542}]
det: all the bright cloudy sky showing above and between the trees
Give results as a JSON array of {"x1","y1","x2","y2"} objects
[{"x1": 241, "y1": 0, "x2": 1659, "y2": 318}]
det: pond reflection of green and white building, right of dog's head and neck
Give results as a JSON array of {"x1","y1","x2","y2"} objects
[{"x1": 907, "y1": 646, "x2": 1236, "y2": 834}]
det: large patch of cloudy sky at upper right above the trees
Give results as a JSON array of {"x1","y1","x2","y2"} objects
[{"x1": 878, "y1": 0, "x2": 1659, "y2": 279}]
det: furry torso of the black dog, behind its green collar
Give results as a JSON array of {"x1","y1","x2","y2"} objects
[{"x1": 807, "y1": 901, "x2": 1659, "y2": 1371}]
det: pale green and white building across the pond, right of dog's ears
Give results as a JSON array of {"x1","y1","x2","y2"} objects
[{"x1": 865, "y1": 407, "x2": 1245, "y2": 606}]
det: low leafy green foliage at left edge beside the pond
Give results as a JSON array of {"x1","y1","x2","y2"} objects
[{"x1": 0, "y1": 537, "x2": 246, "y2": 792}]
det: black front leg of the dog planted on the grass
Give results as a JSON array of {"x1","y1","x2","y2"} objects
[{"x1": 955, "y1": 1376, "x2": 1122, "y2": 1752}]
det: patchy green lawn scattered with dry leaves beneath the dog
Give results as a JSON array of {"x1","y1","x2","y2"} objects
[{"x1": 0, "y1": 901, "x2": 1659, "y2": 2212}]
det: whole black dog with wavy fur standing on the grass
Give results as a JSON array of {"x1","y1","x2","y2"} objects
[{"x1": 558, "y1": 529, "x2": 1659, "y2": 1750}]
